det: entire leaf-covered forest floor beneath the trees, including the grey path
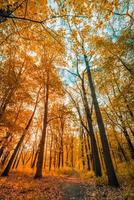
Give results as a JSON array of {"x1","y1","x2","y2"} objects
[{"x1": 0, "y1": 173, "x2": 134, "y2": 200}]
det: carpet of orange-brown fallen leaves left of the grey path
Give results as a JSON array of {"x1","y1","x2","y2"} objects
[{"x1": 0, "y1": 174, "x2": 62, "y2": 200}]
